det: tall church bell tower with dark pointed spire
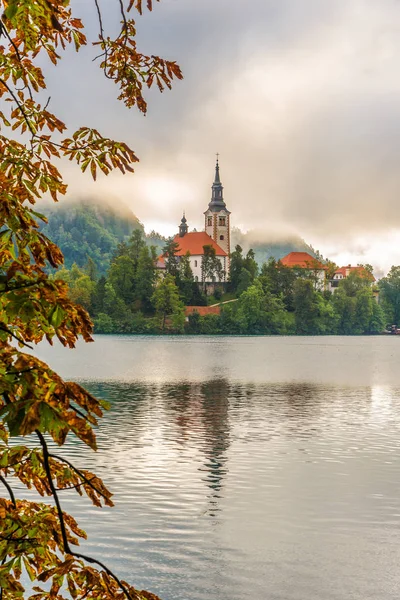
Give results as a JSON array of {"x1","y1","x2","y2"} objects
[{"x1": 204, "y1": 154, "x2": 231, "y2": 264}]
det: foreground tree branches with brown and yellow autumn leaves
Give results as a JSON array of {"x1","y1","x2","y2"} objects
[{"x1": 0, "y1": 0, "x2": 182, "y2": 600}]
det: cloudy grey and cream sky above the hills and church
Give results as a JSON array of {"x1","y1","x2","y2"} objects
[{"x1": 41, "y1": 0, "x2": 400, "y2": 274}]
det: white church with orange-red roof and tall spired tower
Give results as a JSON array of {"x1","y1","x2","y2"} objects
[{"x1": 157, "y1": 157, "x2": 231, "y2": 283}]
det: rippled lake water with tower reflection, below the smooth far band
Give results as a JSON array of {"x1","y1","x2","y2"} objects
[{"x1": 52, "y1": 377, "x2": 400, "y2": 600}]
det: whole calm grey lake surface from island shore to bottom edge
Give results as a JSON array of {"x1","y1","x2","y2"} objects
[{"x1": 28, "y1": 336, "x2": 400, "y2": 600}]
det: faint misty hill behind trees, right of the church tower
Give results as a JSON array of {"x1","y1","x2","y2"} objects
[{"x1": 231, "y1": 227, "x2": 319, "y2": 266}]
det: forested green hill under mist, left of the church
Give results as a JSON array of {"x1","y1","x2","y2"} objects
[{"x1": 39, "y1": 200, "x2": 143, "y2": 274}]
